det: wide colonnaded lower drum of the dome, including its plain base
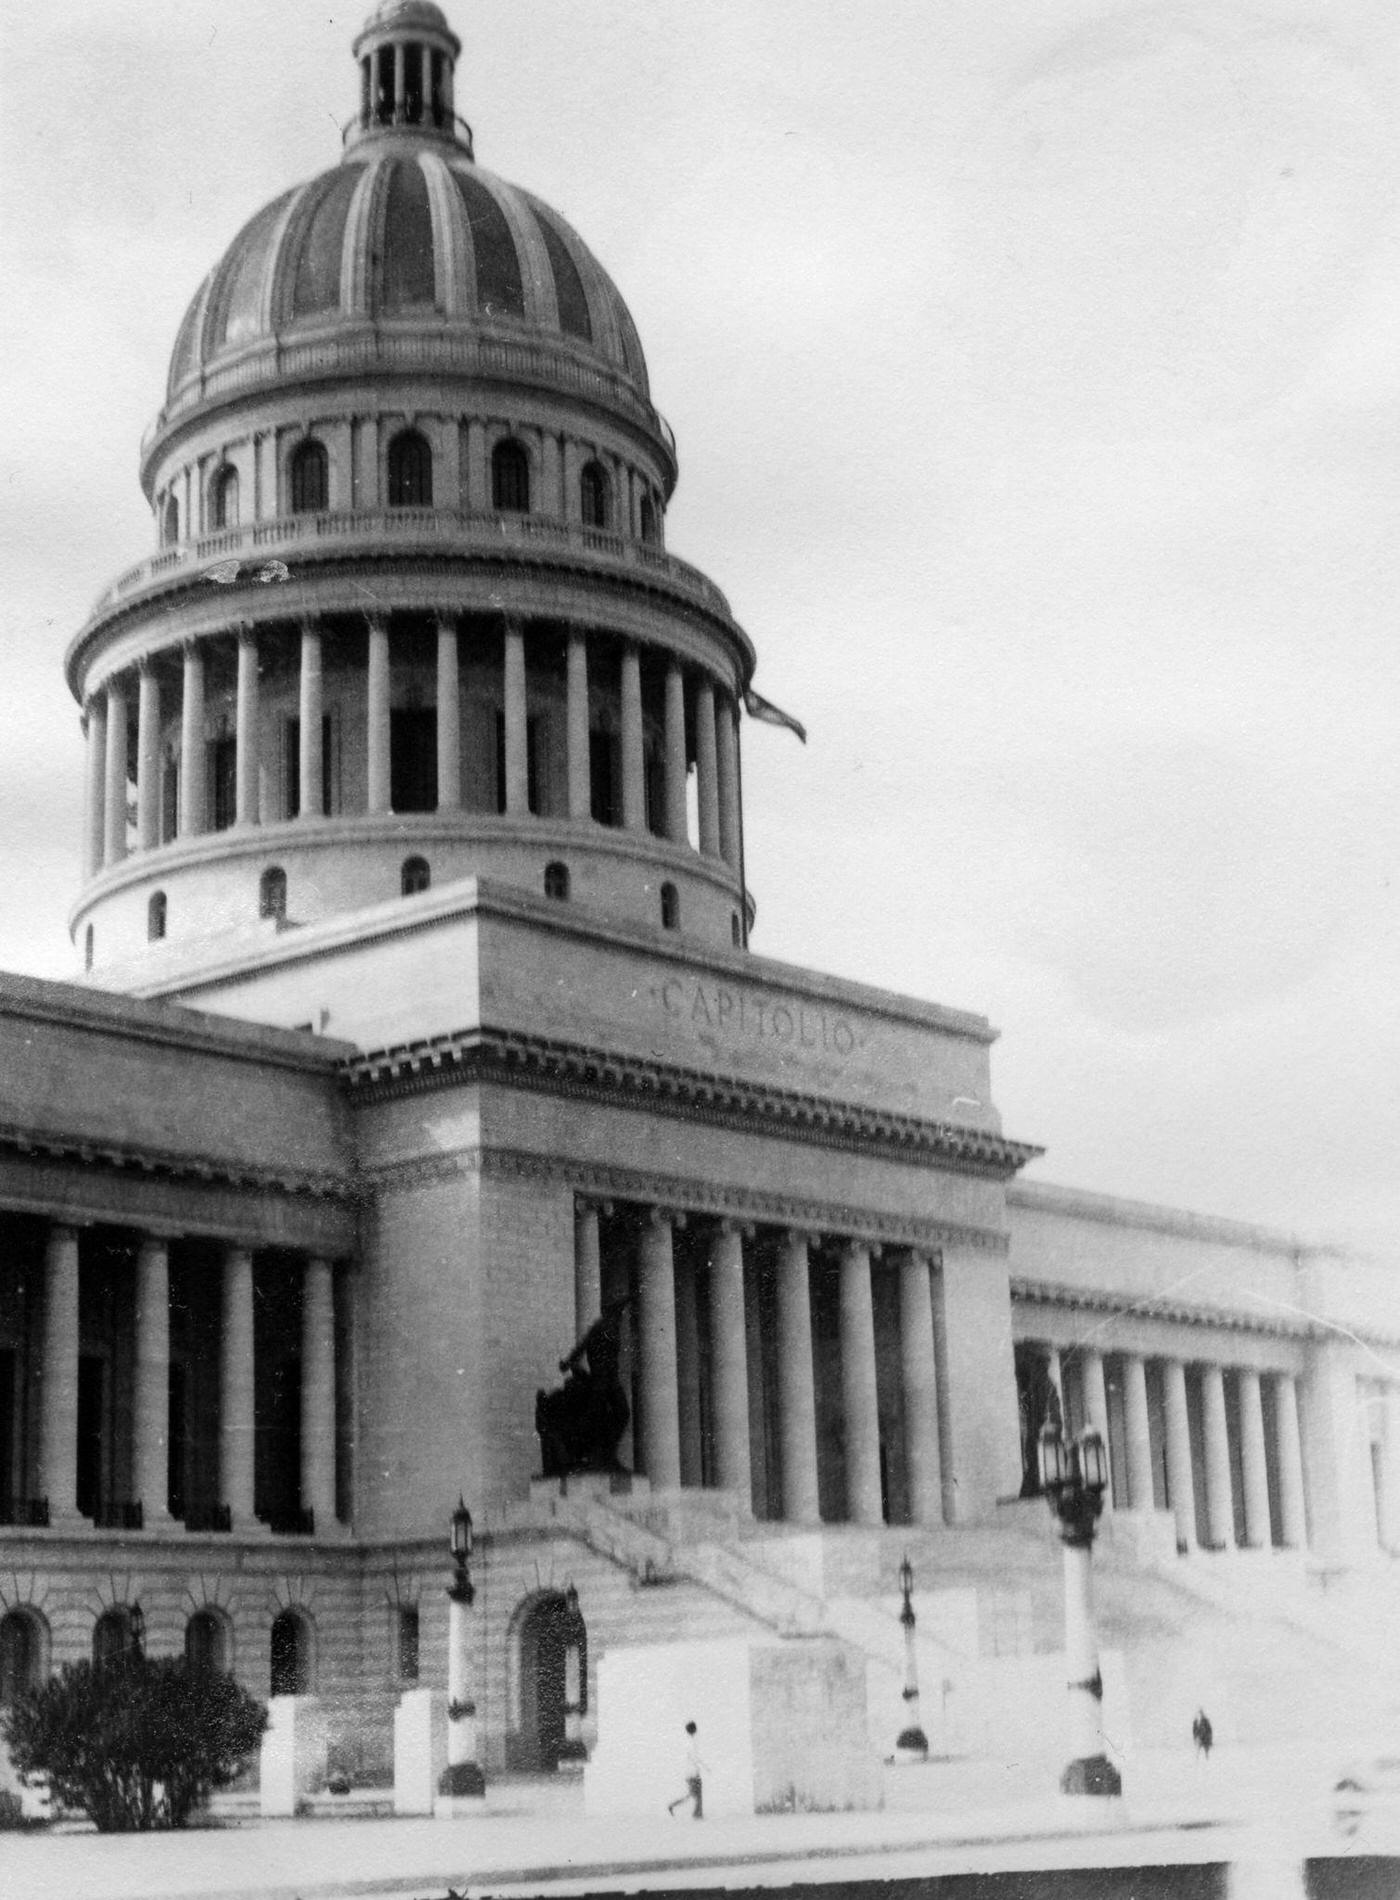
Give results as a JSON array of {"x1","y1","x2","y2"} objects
[{"x1": 74, "y1": 612, "x2": 741, "y2": 963}]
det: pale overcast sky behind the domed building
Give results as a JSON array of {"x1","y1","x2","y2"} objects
[{"x1": 0, "y1": 0, "x2": 1400, "y2": 1250}]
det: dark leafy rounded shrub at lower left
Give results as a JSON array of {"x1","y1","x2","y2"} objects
[{"x1": 0, "y1": 1655, "x2": 268, "y2": 1834}]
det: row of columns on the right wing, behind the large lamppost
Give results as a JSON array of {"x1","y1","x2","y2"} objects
[{"x1": 1049, "y1": 1347, "x2": 1307, "y2": 1549}]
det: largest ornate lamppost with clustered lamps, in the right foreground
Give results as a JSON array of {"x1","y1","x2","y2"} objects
[{"x1": 1039, "y1": 1421, "x2": 1123, "y2": 1794}]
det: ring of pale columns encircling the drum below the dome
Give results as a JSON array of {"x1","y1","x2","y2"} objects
[{"x1": 85, "y1": 616, "x2": 741, "y2": 876}]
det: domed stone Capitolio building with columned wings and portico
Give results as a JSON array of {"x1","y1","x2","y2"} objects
[{"x1": 0, "y1": 0, "x2": 1400, "y2": 1775}]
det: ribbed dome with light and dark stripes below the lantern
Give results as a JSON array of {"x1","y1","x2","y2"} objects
[{"x1": 167, "y1": 152, "x2": 648, "y2": 401}]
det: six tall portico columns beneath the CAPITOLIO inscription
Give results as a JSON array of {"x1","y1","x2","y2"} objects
[{"x1": 574, "y1": 1201, "x2": 942, "y2": 1524}]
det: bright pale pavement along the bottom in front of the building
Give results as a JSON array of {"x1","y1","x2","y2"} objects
[{"x1": 0, "y1": 1752, "x2": 1400, "y2": 1900}]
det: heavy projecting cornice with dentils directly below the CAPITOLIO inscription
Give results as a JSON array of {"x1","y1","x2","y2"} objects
[{"x1": 342, "y1": 1026, "x2": 1041, "y2": 1180}]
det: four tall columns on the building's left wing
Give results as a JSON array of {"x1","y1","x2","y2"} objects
[{"x1": 38, "y1": 1224, "x2": 336, "y2": 1531}]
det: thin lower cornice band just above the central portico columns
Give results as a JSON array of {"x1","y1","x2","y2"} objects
[{"x1": 365, "y1": 1148, "x2": 1009, "y2": 1254}]
